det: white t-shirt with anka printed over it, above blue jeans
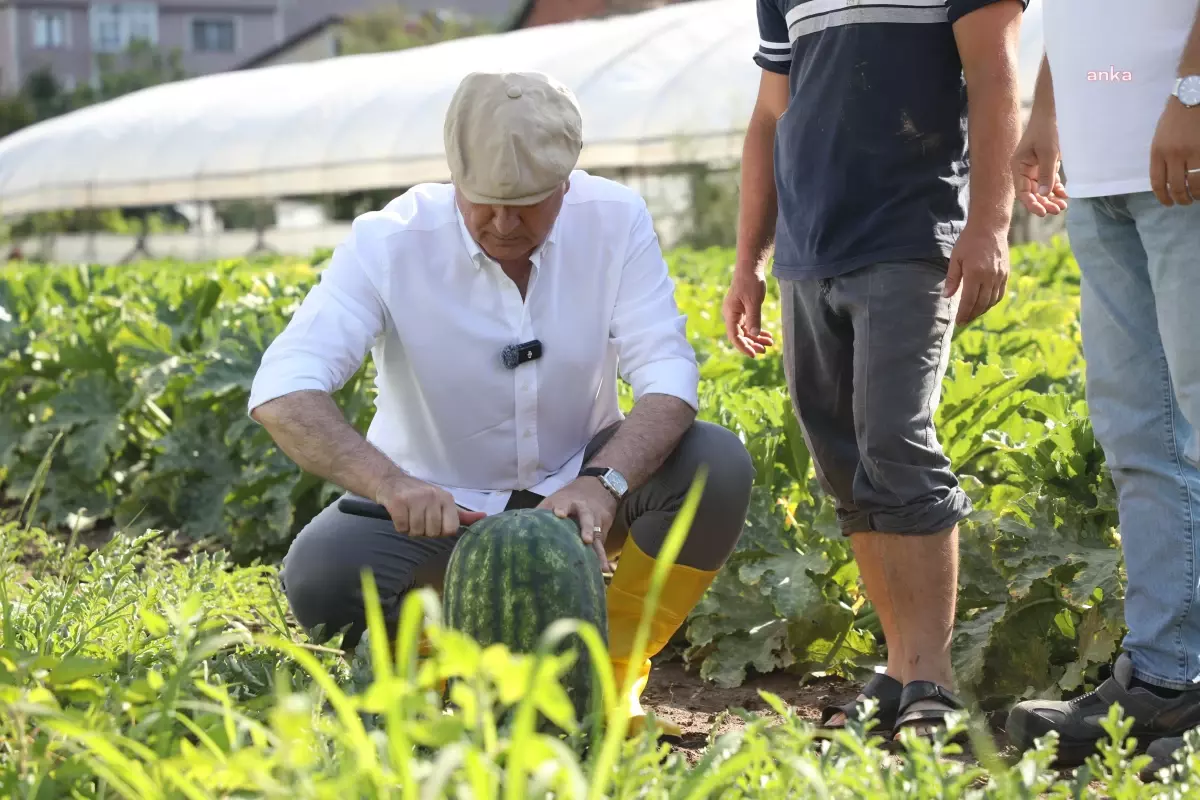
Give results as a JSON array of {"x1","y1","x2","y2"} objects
[{"x1": 1042, "y1": 0, "x2": 1200, "y2": 197}]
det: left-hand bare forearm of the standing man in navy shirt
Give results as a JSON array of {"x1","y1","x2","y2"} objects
[{"x1": 736, "y1": 114, "x2": 779, "y2": 270}]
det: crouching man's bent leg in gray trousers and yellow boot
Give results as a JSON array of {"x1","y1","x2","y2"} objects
[{"x1": 597, "y1": 422, "x2": 755, "y2": 736}]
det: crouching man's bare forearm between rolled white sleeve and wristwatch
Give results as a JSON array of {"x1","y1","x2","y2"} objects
[{"x1": 587, "y1": 395, "x2": 696, "y2": 491}]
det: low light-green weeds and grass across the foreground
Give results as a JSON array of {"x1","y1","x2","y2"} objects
[{"x1": 0, "y1": 515, "x2": 1200, "y2": 800}]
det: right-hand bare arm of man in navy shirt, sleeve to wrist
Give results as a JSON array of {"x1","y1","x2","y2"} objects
[{"x1": 958, "y1": 4, "x2": 1021, "y2": 231}]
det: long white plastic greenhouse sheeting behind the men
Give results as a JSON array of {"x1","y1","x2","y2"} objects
[{"x1": 0, "y1": 0, "x2": 1042, "y2": 216}]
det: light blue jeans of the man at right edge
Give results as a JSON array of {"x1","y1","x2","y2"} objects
[{"x1": 1067, "y1": 192, "x2": 1200, "y2": 688}]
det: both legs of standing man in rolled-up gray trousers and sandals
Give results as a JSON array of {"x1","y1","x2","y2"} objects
[{"x1": 781, "y1": 260, "x2": 971, "y2": 730}]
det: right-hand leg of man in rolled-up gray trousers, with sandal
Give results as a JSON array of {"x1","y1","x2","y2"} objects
[{"x1": 833, "y1": 259, "x2": 971, "y2": 734}]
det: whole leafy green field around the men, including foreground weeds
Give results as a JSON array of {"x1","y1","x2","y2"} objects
[{"x1": 0, "y1": 245, "x2": 1190, "y2": 798}]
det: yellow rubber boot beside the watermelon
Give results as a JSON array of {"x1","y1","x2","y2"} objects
[{"x1": 607, "y1": 536, "x2": 716, "y2": 736}]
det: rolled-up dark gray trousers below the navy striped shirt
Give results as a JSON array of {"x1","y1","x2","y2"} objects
[{"x1": 779, "y1": 259, "x2": 971, "y2": 535}]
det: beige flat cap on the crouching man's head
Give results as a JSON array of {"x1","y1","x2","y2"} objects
[{"x1": 444, "y1": 72, "x2": 583, "y2": 205}]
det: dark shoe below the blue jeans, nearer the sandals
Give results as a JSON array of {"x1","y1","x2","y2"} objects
[{"x1": 1006, "y1": 654, "x2": 1200, "y2": 769}]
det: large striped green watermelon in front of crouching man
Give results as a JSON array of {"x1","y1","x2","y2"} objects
[{"x1": 442, "y1": 509, "x2": 608, "y2": 722}]
